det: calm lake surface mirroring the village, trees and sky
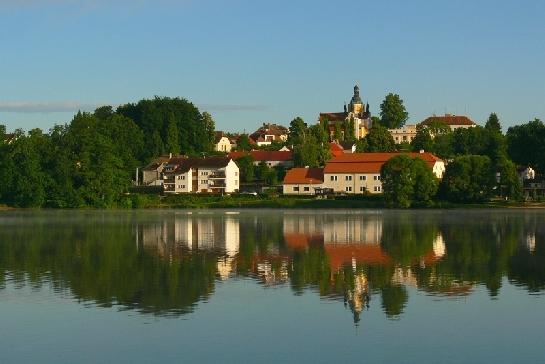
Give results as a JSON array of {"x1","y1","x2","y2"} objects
[{"x1": 0, "y1": 210, "x2": 545, "y2": 363}]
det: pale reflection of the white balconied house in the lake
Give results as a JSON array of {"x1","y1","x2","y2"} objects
[{"x1": 136, "y1": 213, "x2": 240, "y2": 279}]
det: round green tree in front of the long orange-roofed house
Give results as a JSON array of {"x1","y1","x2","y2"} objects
[{"x1": 380, "y1": 154, "x2": 438, "y2": 208}]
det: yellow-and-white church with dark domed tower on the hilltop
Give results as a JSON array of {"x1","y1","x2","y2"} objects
[{"x1": 318, "y1": 85, "x2": 372, "y2": 140}]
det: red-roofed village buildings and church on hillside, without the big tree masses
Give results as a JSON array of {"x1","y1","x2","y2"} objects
[{"x1": 137, "y1": 85, "x2": 545, "y2": 205}]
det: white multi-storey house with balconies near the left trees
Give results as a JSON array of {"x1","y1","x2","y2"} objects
[{"x1": 162, "y1": 157, "x2": 239, "y2": 193}]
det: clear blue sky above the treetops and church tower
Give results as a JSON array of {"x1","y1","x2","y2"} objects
[{"x1": 0, "y1": 0, "x2": 545, "y2": 131}]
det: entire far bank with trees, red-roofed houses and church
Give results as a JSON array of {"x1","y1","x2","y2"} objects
[{"x1": 0, "y1": 85, "x2": 545, "y2": 207}]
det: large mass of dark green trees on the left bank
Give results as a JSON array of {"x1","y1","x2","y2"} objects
[{"x1": 0, "y1": 97, "x2": 214, "y2": 208}]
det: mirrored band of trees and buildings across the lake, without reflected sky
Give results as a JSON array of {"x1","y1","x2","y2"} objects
[{"x1": 0, "y1": 211, "x2": 545, "y2": 323}]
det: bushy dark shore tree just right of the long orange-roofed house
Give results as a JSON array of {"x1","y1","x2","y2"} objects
[{"x1": 440, "y1": 155, "x2": 496, "y2": 202}]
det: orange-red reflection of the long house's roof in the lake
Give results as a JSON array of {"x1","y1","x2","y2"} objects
[{"x1": 325, "y1": 244, "x2": 391, "y2": 270}]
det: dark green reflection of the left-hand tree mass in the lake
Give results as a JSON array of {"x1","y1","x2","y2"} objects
[{"x1": 0, "y1": 215, "x2": 216, "y2": 314}]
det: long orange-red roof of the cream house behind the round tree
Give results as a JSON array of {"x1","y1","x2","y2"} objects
[{"x1": 324, "y1": 153, "x2": 441, "y2": 173}]
